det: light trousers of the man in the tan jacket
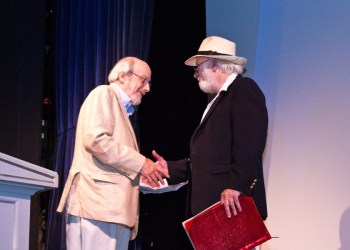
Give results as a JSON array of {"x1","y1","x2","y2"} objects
[{"x1": 66, "y1": 214, "x2": 130, "y2": 250}]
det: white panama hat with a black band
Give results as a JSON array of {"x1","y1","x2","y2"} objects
[{"x1": 185, "y1": 36, "x2": 247, "y2": 66}]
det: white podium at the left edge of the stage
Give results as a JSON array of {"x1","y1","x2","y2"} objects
[{"x1": 0, "y1": 153, "x2": 58, "y2": 250}]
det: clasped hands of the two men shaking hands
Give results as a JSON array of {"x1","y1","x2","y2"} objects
[{"x1": 140, "y1": 150, "x2": 170, "y2": 187}]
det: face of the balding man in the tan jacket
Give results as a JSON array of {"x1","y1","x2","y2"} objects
[{"x1": 123, "y1": 62, "x2": 151, "y2": 106}]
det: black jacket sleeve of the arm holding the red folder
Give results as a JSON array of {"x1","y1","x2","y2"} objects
[{"x1": 230, "y1": 78, "x2": 268, "y2": 194}]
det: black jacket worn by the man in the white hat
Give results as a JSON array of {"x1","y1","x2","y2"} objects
[{"x1": 168, "y1": 75, "x2": 268, "y2": 219}]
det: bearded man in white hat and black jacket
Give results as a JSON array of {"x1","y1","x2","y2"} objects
[{"x1": 156, "y1": 36, "x2": 268, "y2": 219}]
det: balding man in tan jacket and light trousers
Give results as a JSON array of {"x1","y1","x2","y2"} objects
[{"x1": 57, "y1": 57, "x2": 169, "y2": 250}]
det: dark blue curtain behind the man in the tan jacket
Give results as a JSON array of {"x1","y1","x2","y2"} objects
[{"x1": 45, "y1": 0, "x2": 154, "y2": 250}]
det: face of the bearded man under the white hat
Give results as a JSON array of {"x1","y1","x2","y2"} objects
[{"x1": 194, "y1": 57, "x2": 215, "y2": 94}]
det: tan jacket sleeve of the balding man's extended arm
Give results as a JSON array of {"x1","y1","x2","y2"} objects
[{"x1": 79, "y1": 88, "x2": 145, "y2": 179}]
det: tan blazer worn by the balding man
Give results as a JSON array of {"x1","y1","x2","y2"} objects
[{"x1": 57, "y1": 83, "x2": 145, "y2": 239}]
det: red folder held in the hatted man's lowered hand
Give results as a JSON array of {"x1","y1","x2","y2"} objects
[{"x1": 182, "y1": 195, "x2": 271, "y2": 250}]
